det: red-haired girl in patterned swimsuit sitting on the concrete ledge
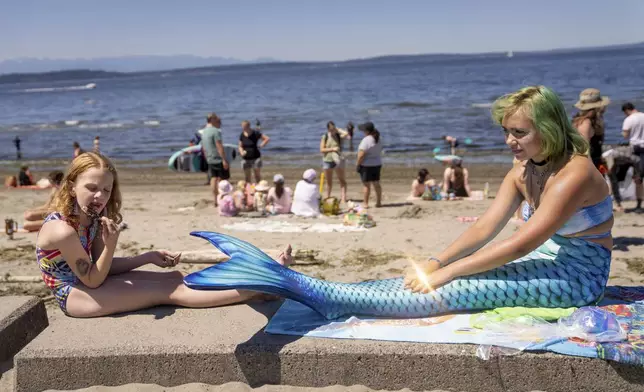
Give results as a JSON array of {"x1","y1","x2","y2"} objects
[{"x1": 36, "y1": 152, "x2": 290, "y2": 317}]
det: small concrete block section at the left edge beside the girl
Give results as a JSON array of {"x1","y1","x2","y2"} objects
[{"x1": 0, "y1": 296, "x2": 49, "y2": 362}]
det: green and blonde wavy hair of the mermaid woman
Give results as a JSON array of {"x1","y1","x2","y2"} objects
[{"x1": 492, "y1": 86, "x2": 589, "y2": 163}]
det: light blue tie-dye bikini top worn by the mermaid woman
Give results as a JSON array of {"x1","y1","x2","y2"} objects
[{"x1": 522, "y1": 196, "x2": 613, "y2": 239}]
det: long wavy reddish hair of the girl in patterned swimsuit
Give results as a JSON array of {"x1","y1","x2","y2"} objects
[{"x1": 48, "y1": 152, "x2": 123, "y2": 225}]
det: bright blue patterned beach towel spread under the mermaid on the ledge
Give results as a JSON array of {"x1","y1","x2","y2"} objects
[{"x1": 266, "y1": 286, "x2": 644, "y2": 366}]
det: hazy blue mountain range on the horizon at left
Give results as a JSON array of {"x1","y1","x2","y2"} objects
[{"x1": 0, "y1": 55, "x2": 279, "y2": 74}]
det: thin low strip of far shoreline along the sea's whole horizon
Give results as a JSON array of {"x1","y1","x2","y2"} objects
[{"x1": 0, "y1": 42, "x2": 644, "y2": 84}]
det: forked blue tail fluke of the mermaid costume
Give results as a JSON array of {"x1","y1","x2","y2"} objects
[{"x1": 184, "y1": 231, "x2": 314, "y2": 308}]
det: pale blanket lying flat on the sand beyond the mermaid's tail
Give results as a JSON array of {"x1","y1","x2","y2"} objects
[{"x1": 223, "y1": 220, "x2": 367, "y2": 233}]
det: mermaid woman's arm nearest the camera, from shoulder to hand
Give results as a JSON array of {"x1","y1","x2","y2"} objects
[{"x1": 431, "y1": 162, "x2": 593, "y2": 286}]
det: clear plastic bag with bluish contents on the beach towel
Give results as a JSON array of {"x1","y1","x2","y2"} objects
[{"x1": 472, "y1": 306, "x2": 627, "y2": 360}]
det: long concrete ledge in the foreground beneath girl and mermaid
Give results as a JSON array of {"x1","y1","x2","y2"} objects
[{"x1": 15, "y1": 302, "x2": 644, "y2": 392}]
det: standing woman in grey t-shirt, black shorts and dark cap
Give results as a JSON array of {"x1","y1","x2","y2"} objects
[{"x1": 356, "y1": 122, "x2": 382, "y2": 208}]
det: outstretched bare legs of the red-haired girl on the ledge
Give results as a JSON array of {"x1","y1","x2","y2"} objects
[{"x1": 67, "y1": 271, "x2": 257, "y2": 317}]
